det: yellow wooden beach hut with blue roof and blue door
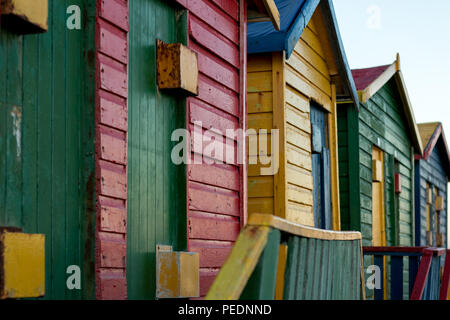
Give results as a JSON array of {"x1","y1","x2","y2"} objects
[{"x1": 247, "y1": 0, "x2": 358, "y2": 230}]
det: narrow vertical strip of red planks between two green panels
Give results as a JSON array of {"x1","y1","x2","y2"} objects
[{"x1": 95, "y1": 0, "x2": 129, "y2": 300}]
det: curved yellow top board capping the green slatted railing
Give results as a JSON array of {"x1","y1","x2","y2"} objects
[{"x1": 248, "y1": 213, "x2": 362, "y2": 240}]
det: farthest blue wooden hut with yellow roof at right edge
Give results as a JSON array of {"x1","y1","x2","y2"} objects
[{"x1": 415, "y1": 122, "x2": 450, "y2": 248}]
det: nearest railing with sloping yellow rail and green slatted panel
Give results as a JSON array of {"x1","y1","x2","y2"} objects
[{"x1": 206, "y1": 214, "x2": 365, "y2": 300}]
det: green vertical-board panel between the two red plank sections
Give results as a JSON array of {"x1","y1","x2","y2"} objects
[{"x1": 127, "y1": 0, "x2": 186, "y2": 299}]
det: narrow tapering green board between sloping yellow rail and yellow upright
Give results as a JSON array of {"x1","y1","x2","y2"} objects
[{"x1": 240, "y1": 229, "x2": 281, "y2": 300}]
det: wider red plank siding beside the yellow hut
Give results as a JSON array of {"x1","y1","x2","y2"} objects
[{"x1": 183, "y1": 0, "x2": 247, "y2": 297}]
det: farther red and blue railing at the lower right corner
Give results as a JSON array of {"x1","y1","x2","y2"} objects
[{"x1": 363, "y1": 247, "x2": 450, "y2": 300}]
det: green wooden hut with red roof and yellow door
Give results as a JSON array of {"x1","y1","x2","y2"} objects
[{"x1": 338, "y1": 56, "x2": 423, "y2": 295}]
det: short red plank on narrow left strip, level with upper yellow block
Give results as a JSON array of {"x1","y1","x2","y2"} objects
[{"x1": 97, "y1": 54, "x2": 128, "y2": 98}]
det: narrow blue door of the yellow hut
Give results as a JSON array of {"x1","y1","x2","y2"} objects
[{"x1": 310, "y1": 104, "x2": 332, "y2": 230}]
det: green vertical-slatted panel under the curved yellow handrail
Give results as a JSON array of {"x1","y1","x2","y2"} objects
[{"x1": 284, "y1": 236, "x2": 361, "y2": 300}]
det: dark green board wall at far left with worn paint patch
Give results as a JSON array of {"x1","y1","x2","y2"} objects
[{"x1": 0, "y1": 0, "x2": 95, "y2": 299}]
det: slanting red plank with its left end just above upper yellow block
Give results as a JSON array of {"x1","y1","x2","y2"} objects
[{"x1": 189, "y1": 16, "x2": 240, "y2": 68}]
